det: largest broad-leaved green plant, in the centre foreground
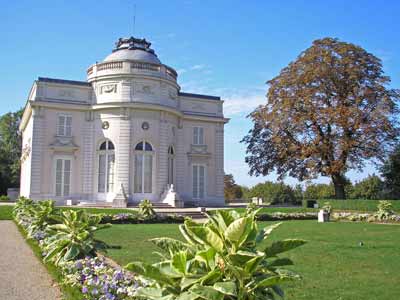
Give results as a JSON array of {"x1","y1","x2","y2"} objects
[{"x1": 126, "y1": 210, "x2": 305, "y2": 300}]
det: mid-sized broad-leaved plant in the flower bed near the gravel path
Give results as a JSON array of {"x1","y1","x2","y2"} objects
[{"x1": 44, "y1": 210, "x2": 109, "y2": 265}]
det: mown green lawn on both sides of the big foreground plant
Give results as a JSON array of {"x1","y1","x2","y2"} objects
[{"x1": 96, "y1": 221, "x2": 400, "y2": 300}]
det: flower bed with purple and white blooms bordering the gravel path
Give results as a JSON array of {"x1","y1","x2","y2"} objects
[{"x1": 14, "y1": 200, "x2": 145, "y2": 300}]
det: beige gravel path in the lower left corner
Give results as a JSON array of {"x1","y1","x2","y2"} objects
[{"x1": 0, "y1": 221, "x2": 62, "y2": 300}]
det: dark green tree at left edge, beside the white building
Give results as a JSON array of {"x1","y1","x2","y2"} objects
[{"x1": 0, "y1": 109, "x2": 23, "y2": 194}]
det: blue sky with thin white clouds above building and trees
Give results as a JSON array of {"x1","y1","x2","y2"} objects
[{"x1": 0, "y1": 0, "x2": 400, "y2": 185}]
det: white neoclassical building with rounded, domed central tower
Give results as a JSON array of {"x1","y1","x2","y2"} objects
[{"x1": 20, "y1": 37, "x2": 228, "y2": 206}]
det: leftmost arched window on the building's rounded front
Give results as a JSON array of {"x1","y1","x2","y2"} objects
[{"x1": 98, "y1": 140, "x2": 115, "y2": 193}]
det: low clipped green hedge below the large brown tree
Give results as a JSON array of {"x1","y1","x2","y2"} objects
[{"x1": 303, "y1": 199, "x2": 400, "y2": 212}]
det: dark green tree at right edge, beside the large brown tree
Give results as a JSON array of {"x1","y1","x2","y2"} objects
[{"x1": 381, "y1": 144, "x2": 400, "y2": 199}]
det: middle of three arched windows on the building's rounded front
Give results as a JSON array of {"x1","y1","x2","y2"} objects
[{"x1": 134, "y1": 141, "x2": 153, "y2": 193}]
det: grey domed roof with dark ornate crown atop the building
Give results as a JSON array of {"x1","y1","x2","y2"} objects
[{"x1": 104, "y1": 37, "x2": 161, "y2": 64}]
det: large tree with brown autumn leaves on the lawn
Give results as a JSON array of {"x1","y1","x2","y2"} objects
[{"x1": 243, "y1": 38, "x2": 400, "y2": 199}]
